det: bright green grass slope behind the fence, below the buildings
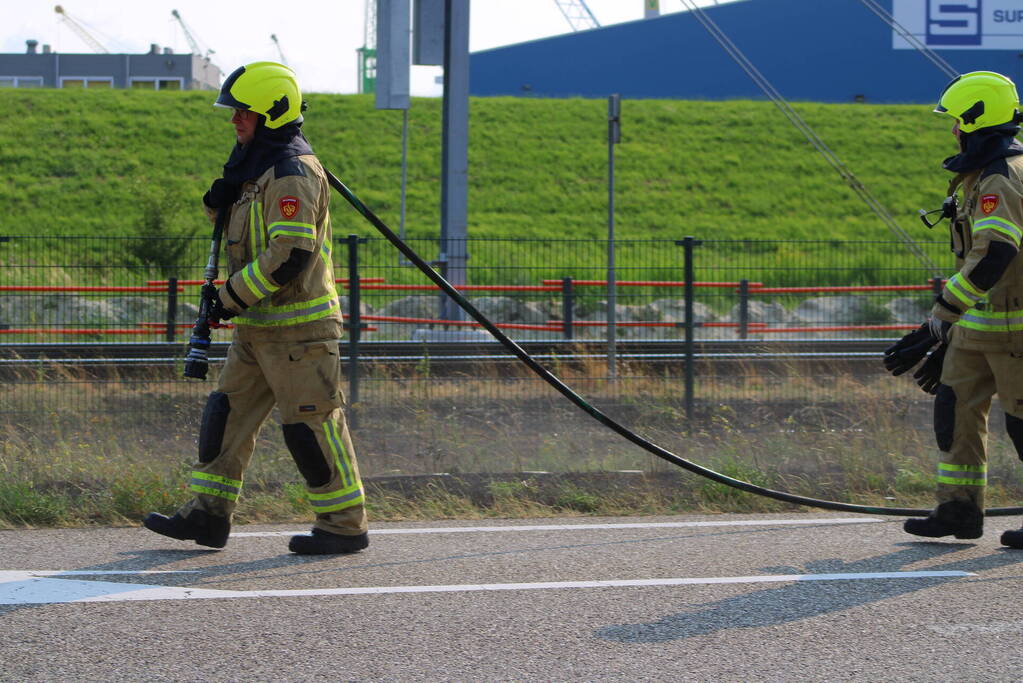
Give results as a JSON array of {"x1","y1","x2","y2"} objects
[{"x1": 0, "y1": 90, "x2": 952, "y2": 283}]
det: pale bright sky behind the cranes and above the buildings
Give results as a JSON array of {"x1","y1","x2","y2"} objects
[{"x1": 0, "y1": 0, "x2": 732, "y2": 96}]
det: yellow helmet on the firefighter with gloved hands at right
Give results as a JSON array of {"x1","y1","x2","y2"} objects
[{"x1": 934, "y1": 72, "x2": 1020, "y2": 133}]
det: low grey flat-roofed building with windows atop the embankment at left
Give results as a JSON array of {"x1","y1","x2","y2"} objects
[{"x1": 0, "y1": 40, "x2": 221, "y2": 90}]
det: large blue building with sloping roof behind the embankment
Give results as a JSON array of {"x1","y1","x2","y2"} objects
[{"x1": 470, "y1": 0, "x2": 1023, "y2": 103}]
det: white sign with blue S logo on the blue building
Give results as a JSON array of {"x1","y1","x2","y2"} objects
[{"x1": 892, "y1": 0, "x2": 1023, "y2": 50}]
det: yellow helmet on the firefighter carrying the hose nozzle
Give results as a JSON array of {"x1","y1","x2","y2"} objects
[{"x1": 214, "y1": 61, "x2": 302, "y2": 129}]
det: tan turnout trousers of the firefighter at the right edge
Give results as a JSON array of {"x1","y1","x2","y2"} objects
[{"x1": 934, "y1": 347, "x2": 1023, "y2": 511}]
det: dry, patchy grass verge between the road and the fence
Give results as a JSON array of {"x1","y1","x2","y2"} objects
[{"x1": 0, "y1": 374, "x2": 1023, "y2": 529}]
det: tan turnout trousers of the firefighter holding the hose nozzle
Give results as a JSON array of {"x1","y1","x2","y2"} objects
[{"x1": 178, "y1": 339, "x2": 367, "y2": 536}]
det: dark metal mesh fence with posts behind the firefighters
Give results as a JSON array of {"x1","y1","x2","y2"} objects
[{"x1": 0, "y1": 235, "x2": 950, "y2": 420}]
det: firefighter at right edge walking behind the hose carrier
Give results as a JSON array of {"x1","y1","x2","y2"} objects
[{"x1": 900, "y1": 72, "x2": 1023, "y2": 548}]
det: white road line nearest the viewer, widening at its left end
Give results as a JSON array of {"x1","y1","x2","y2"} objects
[{"x1": 0, "y1": 572, "x2": 976, "y2": 604}]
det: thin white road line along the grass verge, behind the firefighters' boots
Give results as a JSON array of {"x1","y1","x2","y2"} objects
[{"x1": 231, "y1": 517, "x2": 884, "y2": 539}]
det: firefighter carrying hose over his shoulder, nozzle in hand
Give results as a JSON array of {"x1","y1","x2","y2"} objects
[{"x1": 143, "y1": 61, "x2": 368, "y2": 554}]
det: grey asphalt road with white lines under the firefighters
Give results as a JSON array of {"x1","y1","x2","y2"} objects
[{"x1": 0, "y1": 512, "x2": 1023, "y2": 681}]
